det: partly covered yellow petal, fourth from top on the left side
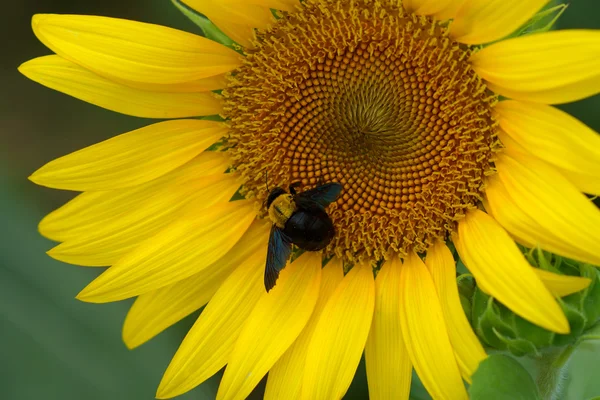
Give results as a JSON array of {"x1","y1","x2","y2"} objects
[{"x1": 39, "y1": 151, "x2": 231, "y2": 242}]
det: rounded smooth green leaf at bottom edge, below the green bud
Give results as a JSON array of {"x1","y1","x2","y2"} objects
[{"x1": 469, "y1": 354, "x2": 541, "y2": 400}]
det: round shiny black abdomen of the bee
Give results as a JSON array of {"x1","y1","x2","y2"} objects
[{"x1": 283, "y1": 208, "x2": 335, "y2": 251}]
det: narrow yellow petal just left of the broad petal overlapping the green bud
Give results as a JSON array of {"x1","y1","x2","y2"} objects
[{"x1": 425, "y1": 242, "x2": 486, "y2": 383}]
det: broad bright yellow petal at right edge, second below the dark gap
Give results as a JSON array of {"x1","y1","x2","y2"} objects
[{"x1": 488, "y1": 153, "x2": 600, "y2": 265}]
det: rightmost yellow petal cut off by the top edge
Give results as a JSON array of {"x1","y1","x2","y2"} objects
[{"x1": 450, "y1": 0, "x2": 549, "y2": 44}]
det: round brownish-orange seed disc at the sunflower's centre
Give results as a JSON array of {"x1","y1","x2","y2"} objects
[{"x1": 223, "y1": 0, "x2": 499, "y2": 260}]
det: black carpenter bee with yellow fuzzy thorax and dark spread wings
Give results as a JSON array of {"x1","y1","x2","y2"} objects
[{"x1": 265, "y1": 183, "x2": 342, "y2": 292}]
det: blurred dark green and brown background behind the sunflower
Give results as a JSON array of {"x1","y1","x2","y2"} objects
[{"x1": 0, "y1": 0, "x2": 600, "y2": 400}]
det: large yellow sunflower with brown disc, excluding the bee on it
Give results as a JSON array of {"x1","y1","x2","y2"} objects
[{"x1": 20, "y1": 0, "x2": 600, "y2": 400}]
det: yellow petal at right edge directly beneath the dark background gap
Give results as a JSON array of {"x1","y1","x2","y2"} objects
[{"x1": 494, "y1": 100, "x2": 600, "y2": 195}]
